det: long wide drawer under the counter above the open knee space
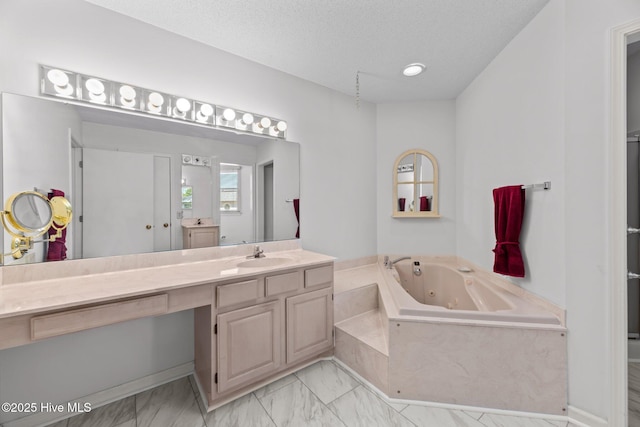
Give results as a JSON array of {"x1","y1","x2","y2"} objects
[{"x1": 31, "y1": 294, "x2": 168, "y2": 340}]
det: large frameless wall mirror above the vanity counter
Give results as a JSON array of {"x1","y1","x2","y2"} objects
[{"x1": 2, "y1": 93, "x2": 300, "y2": 265}]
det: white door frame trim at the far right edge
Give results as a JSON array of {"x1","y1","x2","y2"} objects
[{"x1": 608, "y1": 15, "x2": 640, "y2": 425}]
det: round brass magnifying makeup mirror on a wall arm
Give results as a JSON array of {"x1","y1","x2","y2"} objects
[{"x1": 0, "y1": 191, "x2": 73, "y2": 259}]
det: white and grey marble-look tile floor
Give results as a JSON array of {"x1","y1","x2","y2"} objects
[{"x1": 45, "y1": 360, "x2": 576, "y2": 427}]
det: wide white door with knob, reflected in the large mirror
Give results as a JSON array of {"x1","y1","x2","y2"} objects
[{"x1": 82, "y1": 149, "x2": 154, "y2": 258}]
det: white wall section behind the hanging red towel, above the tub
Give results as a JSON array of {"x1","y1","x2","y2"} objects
[{"x1": 456, "y1": 2, "x2": 565, "y2": 306}]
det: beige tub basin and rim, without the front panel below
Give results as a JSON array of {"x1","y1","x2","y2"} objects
[{"x1": 383, "y1": 257, "x2": 564, "y2": 326}]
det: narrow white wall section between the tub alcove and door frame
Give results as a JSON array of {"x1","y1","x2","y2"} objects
[{"x1": 565, "y1": 0, "x2": 640, "y2": 416}]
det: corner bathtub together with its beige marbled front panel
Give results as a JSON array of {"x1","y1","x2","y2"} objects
[{"x1": 378, "y1": 256, "x2": 567, "y2": 415}]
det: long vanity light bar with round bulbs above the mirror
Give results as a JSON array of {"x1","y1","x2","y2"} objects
[{"x1": 40, "y1": 65, "x2": 287, "y2": 139}]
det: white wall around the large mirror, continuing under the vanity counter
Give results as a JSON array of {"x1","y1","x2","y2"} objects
[{"x1": 0, "y1": 0, "x2": 376, "y2": 418}]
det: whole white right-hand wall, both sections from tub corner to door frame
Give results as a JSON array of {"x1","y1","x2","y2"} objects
[{"x1": 457, "y1": 0, "x2": 640, "y2": 418}]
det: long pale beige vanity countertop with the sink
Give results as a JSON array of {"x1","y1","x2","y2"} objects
[{"x1": 0, "y1": 249, "x2": 334, "y2": 319}]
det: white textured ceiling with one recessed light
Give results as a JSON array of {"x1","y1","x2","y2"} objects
[{"x1": 87, "y1": 0, "x2": 549, "y2": 103}]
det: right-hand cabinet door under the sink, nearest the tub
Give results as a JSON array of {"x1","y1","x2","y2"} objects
[{"x1": 287, "y1": 288, "x2": 333, "y2": 363}]
